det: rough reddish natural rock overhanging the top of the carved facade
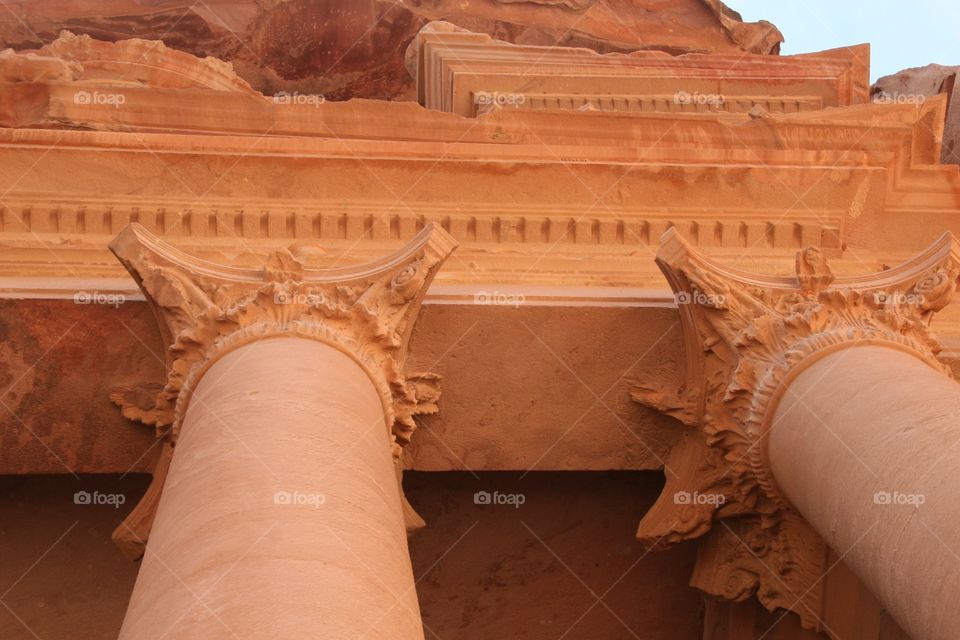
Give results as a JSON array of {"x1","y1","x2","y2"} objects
[{"x1": 0, "y1": 0, "x2": 783, "y2": 100}]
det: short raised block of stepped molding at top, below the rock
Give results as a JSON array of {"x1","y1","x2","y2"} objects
[{"x1": 405, "y1": 21, "x2": 870, "y2": 117}]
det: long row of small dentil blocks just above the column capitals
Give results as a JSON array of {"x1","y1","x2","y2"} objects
[{"x1": 0, "y1": 195, "x2": 845, "y2": 250}]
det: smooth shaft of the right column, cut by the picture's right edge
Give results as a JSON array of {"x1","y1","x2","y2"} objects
[{"x1": 769, "y1": 346, "x2": 960, "y2": 640}]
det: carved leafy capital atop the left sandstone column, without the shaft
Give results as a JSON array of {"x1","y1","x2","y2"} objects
[{"x1": 110, "y1": 224, "x2": 456, "y2": 557}]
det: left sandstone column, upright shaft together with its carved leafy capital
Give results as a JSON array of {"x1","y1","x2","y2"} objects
[{"x1": 105, "y1": 225, "x2": 453, "y2": 640}]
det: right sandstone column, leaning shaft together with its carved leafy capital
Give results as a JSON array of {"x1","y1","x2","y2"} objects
[{"x1": 634, "y1": 232, "x2": 960, "y2": 640}]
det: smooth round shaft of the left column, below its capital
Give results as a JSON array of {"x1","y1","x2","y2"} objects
[{"x1": 120, "y1": 337, "x2": 423, "y2": 640}]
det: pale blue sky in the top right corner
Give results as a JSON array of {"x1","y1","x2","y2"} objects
[{"x1": 726, "y1": 0, "x2": 960, "y2": 82}]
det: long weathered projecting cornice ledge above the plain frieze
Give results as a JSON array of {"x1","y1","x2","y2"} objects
[{"x1": 0, "y1": 101, "x2": 928, "y2": 166}]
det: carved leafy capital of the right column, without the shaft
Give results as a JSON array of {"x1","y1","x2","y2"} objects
[{"x1": 633, "y1": 229, "x2": 960, "y2": 629}]
